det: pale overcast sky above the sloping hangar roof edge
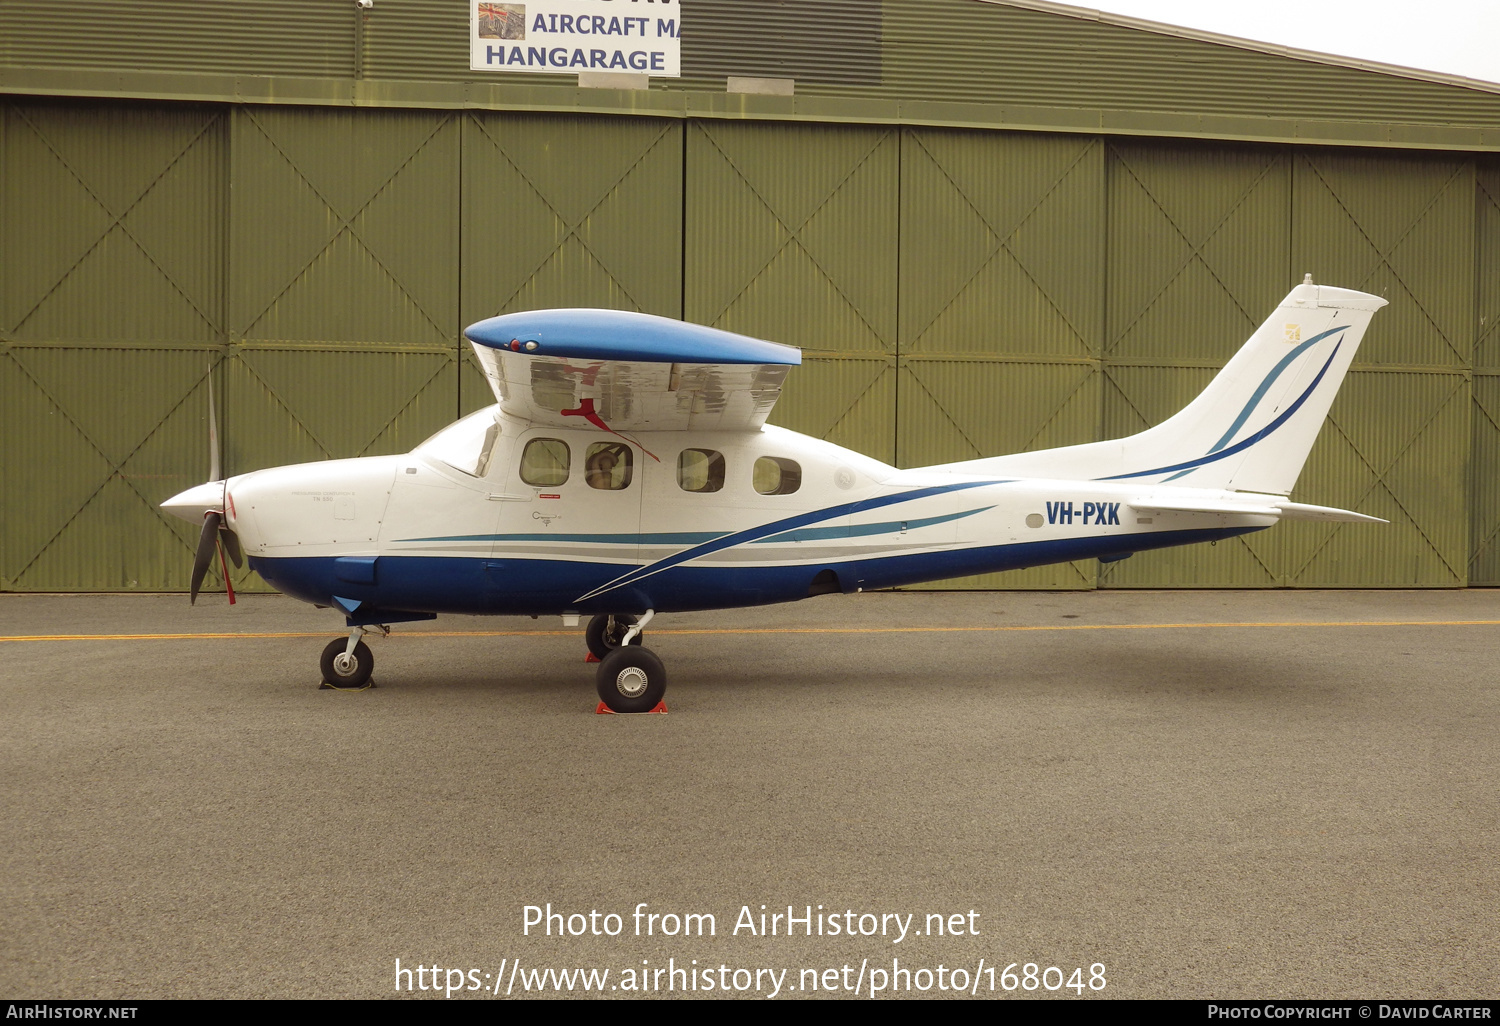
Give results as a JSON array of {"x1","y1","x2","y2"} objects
[{"x1": 1062, "y1": 0, "x2": 1500, "y2": 83}]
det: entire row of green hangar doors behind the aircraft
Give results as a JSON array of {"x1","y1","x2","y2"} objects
[{"x1": 0, "y1": 99, "x2": 1500, "y2": 591}]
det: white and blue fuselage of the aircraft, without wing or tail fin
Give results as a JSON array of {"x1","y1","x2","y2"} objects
[{"x1": 225, "y1": 408, "x2": 1275, "y2": 621}]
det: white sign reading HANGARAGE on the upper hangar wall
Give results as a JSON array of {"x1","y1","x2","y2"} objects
[{"x1": 470, "y1": 0, "x2": 683, "y2": 78}]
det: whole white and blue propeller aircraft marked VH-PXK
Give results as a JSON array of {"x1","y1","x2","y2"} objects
[{"x1": 162, "y1": 276, "x2": 1385, "y2": 713}]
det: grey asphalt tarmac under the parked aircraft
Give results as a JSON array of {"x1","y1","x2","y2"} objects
[{"x1": 0, "y1": 590, "x2": 1500, "y2": 1001}]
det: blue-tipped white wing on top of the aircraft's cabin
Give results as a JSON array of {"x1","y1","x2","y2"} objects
[{"x1": 464, "y1": 309, "x2": 803, "y2": 431}]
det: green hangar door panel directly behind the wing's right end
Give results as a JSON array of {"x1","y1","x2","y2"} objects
[{"x1": 683, "y1": 122, "x2": 899, "y2": 461}]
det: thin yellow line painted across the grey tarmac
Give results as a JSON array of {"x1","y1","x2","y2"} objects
[{"x1": 0, "y1": 620, "x2": 1500, "y2": 642}]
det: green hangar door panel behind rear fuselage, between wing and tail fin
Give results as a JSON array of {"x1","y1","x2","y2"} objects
[{"x1": 897, "y1": 129, "x2": 1106, "y2": 588}]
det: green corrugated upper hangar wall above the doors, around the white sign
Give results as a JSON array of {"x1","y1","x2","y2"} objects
[{"x1": 0, "y1": 0, "x2": 1500, "y2": 143}]
